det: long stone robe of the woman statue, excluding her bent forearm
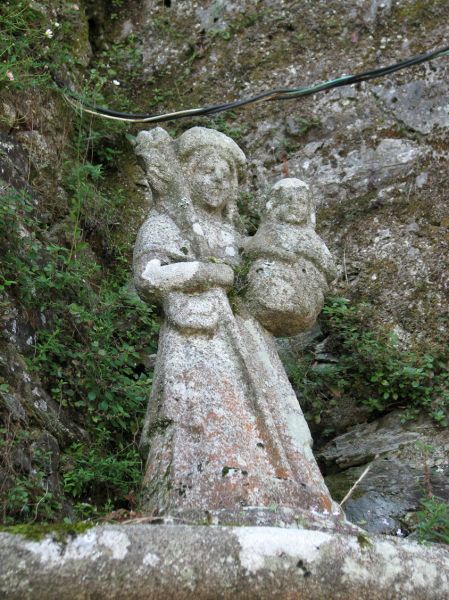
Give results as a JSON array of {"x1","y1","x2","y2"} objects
[{"x1": 134, "y1": 210, "x2": 335, "y2": 514}]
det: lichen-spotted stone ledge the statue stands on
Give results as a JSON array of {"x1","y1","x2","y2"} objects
[{"x1": 0, "y1": 525, "x2": 449, "y2": 600}]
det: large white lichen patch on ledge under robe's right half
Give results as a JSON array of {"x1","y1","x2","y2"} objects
[{"x1": 233, "y1": 527, "x2": 332, "y2": 573}]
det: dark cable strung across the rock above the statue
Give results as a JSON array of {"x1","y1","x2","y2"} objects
[{"x1": 54, "y1": 46, "x2": 449, "y2": 123}]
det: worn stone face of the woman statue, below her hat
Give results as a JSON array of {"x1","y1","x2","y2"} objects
[{"x1": 188, "y1": 150, "x2": 237, "y2": 210}]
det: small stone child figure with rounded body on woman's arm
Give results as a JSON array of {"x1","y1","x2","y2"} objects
[{"x1": 244, "y1": 178, "x2": 336, "y2": 336}]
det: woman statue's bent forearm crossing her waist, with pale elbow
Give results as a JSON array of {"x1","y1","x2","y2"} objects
[{"x1": 135, "y1": 258, "x2": 234, "y2": 301}]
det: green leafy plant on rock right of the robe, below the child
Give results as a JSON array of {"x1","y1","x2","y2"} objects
[{"x1": 289, "y1": 298, "x2": 449, "y2": 425}]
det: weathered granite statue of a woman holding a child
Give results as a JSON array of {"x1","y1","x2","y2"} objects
[{"x1": 134, "y1": 127, "x2": 341, "y2": 524}]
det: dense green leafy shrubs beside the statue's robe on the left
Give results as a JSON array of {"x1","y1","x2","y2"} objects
[{"x1": 0, "y1": 119, "x2": 158, "y2": 523}]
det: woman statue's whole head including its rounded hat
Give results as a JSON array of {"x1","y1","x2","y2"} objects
[{"x1": 176, "y1": 127, "x2": 246, "y2": 211}]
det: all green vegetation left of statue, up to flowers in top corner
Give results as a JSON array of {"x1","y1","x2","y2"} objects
[{"x1": 0, "y1": 1, "x2": 158, "y2": 524}]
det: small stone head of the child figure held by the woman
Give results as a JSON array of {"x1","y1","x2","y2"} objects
[{"x1": 265, "y1": 177, "x2": 315, "y2": 227}]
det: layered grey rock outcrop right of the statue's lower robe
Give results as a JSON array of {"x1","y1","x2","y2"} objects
[{"x1": 318, "y1": 412, "x2": 449, "y2": 535}]
